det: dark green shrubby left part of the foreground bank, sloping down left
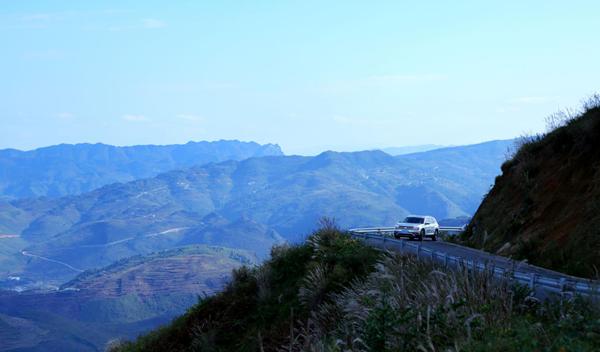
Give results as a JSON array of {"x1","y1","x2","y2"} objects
[{"x1": 114, "y1": 220, "x2": 381, "y2": 351}]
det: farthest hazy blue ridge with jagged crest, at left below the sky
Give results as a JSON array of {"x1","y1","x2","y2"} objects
[{"x1": 0, "y1": 141, "x2": 283, "y2": 199}]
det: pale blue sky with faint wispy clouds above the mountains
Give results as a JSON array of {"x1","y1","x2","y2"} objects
[{"x1": 0, "y1": 0, "x2": 600, "y2": 154}]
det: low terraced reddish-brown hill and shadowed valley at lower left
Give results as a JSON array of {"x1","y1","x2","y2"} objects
[{"x1": 0, "y1": 246, "x2": 256, "y2": 351}]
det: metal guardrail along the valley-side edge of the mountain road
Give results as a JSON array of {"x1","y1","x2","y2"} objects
[{"x1": 349, "y1": 227, "x2": 600, "y2": 296}]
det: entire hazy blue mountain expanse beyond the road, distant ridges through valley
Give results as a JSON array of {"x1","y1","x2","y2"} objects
[{"x1": 0, "y1": 140, "x2": 514, "y2": 352}]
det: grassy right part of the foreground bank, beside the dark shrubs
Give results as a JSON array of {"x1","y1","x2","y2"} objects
[{"x1": 281, "y1": 254, "x2": 600, "y2": 352}]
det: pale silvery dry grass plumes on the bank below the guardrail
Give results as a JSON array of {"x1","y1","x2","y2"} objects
[{"x1": 281, "y1": 253, "x2": 600, "y2": 352}]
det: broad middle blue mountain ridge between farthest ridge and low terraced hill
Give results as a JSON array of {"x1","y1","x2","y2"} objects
[{"x1": 0, "y1": 141, "x2": 511, "y2": 284}]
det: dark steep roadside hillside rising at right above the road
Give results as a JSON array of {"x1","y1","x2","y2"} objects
[{"x1": 464, "y1": 102, "x2": 600, "y2": 277}]
